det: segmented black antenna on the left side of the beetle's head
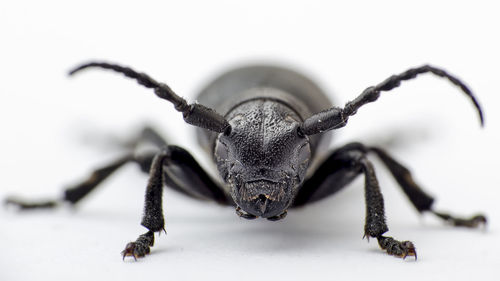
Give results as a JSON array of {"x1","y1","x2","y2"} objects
[{"x1": 69, "y1": 62, "x2": 231, "y2": 133}]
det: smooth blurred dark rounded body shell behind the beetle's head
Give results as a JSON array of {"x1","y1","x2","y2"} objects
[{"x1": 196, "y1": 65, "x2": 333, "y2": 156}]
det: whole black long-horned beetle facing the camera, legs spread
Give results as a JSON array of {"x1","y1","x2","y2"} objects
[{"x1": 6, "y1": 62, "x2": 486, "y2": 259}]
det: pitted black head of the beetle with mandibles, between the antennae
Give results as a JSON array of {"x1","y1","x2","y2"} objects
[{"x1": 215, "y1": 101, "x2": 311, "y2": 219}]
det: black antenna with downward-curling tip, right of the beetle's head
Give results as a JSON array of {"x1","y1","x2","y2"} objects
[{"x1": 300, "y1": 65, "x2": 484, "y2": 135}]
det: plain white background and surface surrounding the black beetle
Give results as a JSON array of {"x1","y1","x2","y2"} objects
[{"x1": 0, "y1": 0, "x2": 500, "y2": 280}]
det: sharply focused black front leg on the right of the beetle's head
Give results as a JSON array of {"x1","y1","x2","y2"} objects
[{"x1": 294, "y1": 144, "x2": 417, "y2": 258}]
